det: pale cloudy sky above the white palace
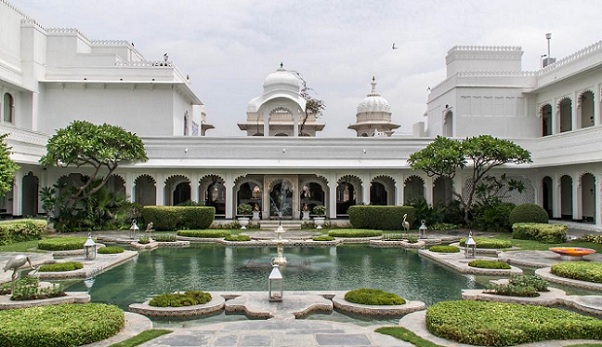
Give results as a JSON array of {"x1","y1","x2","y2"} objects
[{"x1": 9, "y1": 0, "x2": 602, "y2": 137}]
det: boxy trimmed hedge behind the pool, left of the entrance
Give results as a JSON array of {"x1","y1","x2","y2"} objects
[{"x1": 142, "y1": 206, "x2": 215, "y2": 230}]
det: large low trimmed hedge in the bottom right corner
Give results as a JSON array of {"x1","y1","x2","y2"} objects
[{"x1": 426, "y1": 300, "x2": 602, "y2": 346}]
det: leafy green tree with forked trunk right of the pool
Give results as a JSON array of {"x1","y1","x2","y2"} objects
[{"x1": 408, "y1": 135, "x2": 532, "y2": 225}]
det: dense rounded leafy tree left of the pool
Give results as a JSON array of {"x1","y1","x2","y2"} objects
[{"x1": 40, "y1": 121, "x2": 148, "y2": 228}]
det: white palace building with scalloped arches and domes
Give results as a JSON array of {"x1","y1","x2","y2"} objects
[{"x1": 0, "y1": 0, "x2": 602, "y2": 230}]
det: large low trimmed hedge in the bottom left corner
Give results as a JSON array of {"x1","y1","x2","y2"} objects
[{"x1": 0, "y1": 304, "x2": 125, "y2": 347}]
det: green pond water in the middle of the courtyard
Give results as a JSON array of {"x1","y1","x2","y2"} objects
[{"x1": 68, "y1": 244, "x2": 481, "y2": 309}]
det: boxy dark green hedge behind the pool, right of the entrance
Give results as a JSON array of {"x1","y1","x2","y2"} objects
[{"x1": 347, "y1": 205, "x2": 416, "y2": 230}]
